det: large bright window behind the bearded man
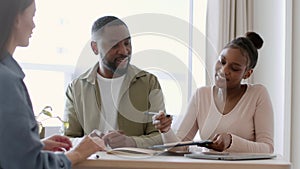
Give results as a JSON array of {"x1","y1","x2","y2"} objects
[{"x1": 15, "y1": 0, "x2": 206, "y2": 125}]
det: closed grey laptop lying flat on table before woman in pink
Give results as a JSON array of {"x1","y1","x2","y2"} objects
[{"x1": 184, "y1": 152, "x2": 276, "y2": 161}]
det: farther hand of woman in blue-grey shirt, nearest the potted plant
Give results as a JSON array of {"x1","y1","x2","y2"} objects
[{"x1": 41, "y1": 135, "x2": 72, "y2": 151}]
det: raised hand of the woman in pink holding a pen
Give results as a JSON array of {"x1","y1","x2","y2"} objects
[{"x1": 152, "y1": 111, "x2": 173, "y2": 133}]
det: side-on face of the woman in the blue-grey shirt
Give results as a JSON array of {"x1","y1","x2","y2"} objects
[{"x1": 12, "y1": 1, "x2": 36, "y2": 47}]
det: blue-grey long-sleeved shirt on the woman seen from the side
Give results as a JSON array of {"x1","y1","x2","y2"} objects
[{"x1": 0, "y1": 52, "x2": 71, "y2": 169}]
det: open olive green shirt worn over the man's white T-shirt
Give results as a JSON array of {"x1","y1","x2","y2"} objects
[{"x1": 64, "y1": 63, "x2": 165, "y2": 148}]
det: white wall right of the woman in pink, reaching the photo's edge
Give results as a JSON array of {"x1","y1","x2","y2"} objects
[{"x1": 254, "y1": 0, "x2": 300, "y2": 169}]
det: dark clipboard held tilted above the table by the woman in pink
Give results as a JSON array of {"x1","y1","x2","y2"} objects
[{"x1": 148, "y1": 140, "x2": 213, "y2": 150}]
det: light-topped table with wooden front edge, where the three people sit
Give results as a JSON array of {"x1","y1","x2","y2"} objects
[{"x1": 73, "y1": 152, "x2": 291, "y2": 169}]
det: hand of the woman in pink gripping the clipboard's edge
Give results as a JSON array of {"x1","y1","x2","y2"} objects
[{"x1": 208, "y1": 133, "x2": 232, "y2": 151}]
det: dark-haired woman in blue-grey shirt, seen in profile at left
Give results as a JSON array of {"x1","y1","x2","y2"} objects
[{"x1": 0, "y1": 0, "x2": 105, "y2": 169}]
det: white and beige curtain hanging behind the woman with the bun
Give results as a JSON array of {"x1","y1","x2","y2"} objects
[{"x1": 206, "y1": 0, "x2": 253, "y2": 85}]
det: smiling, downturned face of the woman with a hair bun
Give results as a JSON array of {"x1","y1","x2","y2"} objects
[{"x1": 215, "y1": 48, "x2": 252, "y2": 89}]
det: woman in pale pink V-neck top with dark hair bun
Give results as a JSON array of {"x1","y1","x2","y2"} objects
[{"x1": 153, "y1": 32, "x2": 274, "y2": 153}]
